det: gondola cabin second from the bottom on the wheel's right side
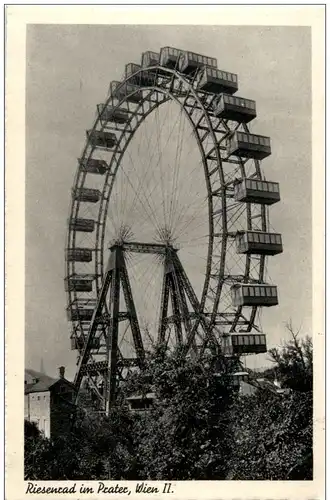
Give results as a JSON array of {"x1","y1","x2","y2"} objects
[{"x1": 231, "y1": 283, "x2": 278, "y2": 307}]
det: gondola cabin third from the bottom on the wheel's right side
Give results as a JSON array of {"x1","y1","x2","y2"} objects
[{"x1": 235, "y1": 231, "x2": 283, "y2": 255}]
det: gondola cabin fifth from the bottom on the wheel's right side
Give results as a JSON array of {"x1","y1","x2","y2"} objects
[{"x1": 227, "y1": 131, "x2": 272, "y2": 160}]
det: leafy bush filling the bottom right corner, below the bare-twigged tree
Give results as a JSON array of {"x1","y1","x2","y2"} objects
[{"x1": 228, "y1": 391, "x2": 313, "y2": 480}]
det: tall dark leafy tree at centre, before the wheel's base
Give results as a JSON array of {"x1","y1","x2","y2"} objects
[{"x1": 121, "y1": 349, "x2": 240, "y2": 480}]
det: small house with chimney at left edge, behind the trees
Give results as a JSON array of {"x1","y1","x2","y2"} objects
[{"x1": 24, "y1": 366, "x2": 75, "y2": 438}]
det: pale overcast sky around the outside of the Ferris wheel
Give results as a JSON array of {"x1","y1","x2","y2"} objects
[{"x1": 25, "y1": 25, "x2": 312, "y2": 378}]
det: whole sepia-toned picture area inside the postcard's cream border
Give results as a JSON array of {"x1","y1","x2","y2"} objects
[{"x1": 7, "y1": 6, "x2": 324, "y2": 498}]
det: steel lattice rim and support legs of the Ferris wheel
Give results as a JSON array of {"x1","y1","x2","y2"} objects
[{"x1": 66, "y1": 48, "x2": 282, "y2": 411}]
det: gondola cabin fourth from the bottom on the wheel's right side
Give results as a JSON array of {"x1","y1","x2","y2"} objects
[{"x1": 234, "y1": 179, "x2": 281, "y2": 205}]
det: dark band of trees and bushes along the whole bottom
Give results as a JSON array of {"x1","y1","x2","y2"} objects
[{"x1": 25, "y1": 331, "x2": 313, "y2": 480}]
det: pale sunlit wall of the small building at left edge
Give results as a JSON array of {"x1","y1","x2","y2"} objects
[{"x1": 24, "y1": 391, "x2": 50, "y2": 438}]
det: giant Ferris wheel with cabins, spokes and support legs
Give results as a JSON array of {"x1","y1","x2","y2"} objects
[{"x1": 65, "y1": 47, "x2": 282, "y2": 411}]
